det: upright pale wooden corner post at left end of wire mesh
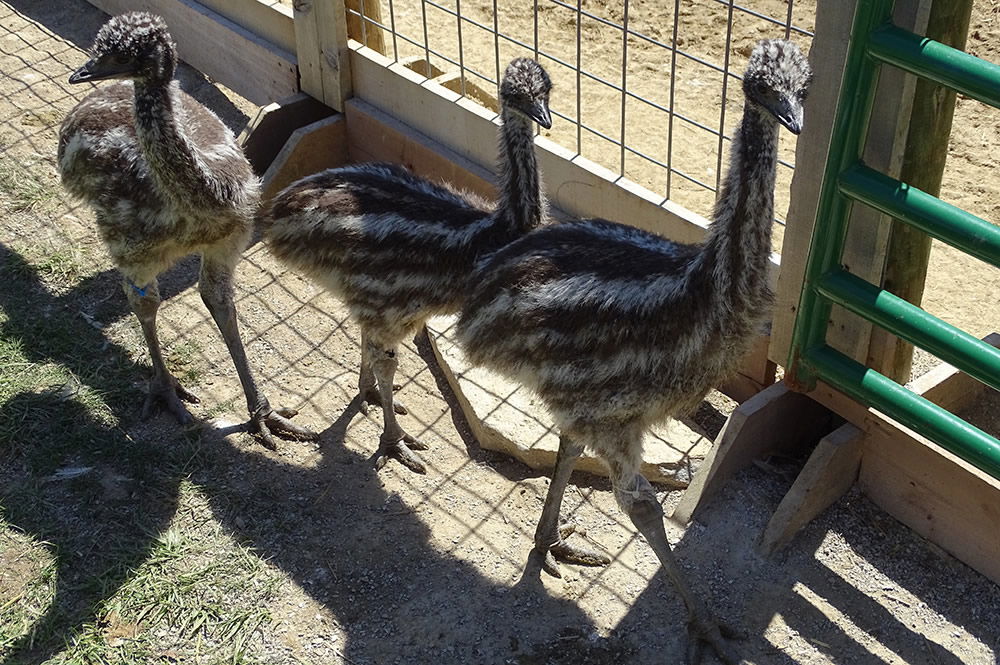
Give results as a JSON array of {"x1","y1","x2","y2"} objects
[{"x1": 294, "y1": 0, "x2": 351, "y2": 111}]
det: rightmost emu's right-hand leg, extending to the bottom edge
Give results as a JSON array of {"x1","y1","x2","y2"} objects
[{"x1": 615, "y1": 474, "x2": 740, "y2": 665}]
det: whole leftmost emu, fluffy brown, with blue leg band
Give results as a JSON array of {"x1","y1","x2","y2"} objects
[{"x1": 58, "y1": 12, "x2": 315, "y2": 448}]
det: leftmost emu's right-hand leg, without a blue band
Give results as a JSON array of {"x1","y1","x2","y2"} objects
[{"x1": 198, "y1": 255, "x2": 319, "y2": 450}]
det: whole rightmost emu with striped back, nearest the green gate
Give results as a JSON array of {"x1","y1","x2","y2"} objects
[{"x1": 458, "y1": 41, "x2": 811, "y2": 662}]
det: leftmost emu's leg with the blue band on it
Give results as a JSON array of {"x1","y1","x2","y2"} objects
[{"x1": 122, "y1": 279, "x2": 198, "y2": 425}]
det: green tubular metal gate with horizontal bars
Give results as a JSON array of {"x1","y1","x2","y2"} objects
[{"x1": 789, "y1": 0, "x2": 1000, "y2": 478}]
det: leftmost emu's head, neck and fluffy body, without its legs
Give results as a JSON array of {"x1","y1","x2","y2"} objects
[{"x1": 58, "y1": 12, "x2": 260, "y2": 284}]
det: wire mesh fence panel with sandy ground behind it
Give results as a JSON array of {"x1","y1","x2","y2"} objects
[{"x1": 348, "y1": 0, "x2": 815, "y2": 236}]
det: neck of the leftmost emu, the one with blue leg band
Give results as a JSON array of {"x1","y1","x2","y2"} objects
[{"x1": 135, "y1": 79, "x2": 212, "y2": 208}]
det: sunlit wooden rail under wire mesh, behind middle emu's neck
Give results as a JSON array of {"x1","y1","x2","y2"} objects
[{"x1": 351, "y1": 42, "x2": 778, "y2": 287}]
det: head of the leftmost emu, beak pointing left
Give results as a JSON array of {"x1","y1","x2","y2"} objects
[{"x1": 69, "y1": 12, "x2": 177, "y2": 83}]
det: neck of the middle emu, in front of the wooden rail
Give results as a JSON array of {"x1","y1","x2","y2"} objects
[{"x1": 497, "y1": 108, "x2": 544, "y2": 233}]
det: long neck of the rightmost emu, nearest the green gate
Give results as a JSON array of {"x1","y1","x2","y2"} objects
[{"x1": 693, "y1": 104, "x2": 778, "y2": 316}]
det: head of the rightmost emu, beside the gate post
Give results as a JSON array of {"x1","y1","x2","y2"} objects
[{"x1": 743, "y1": 39, "x2": 812, "y2": 134}]
